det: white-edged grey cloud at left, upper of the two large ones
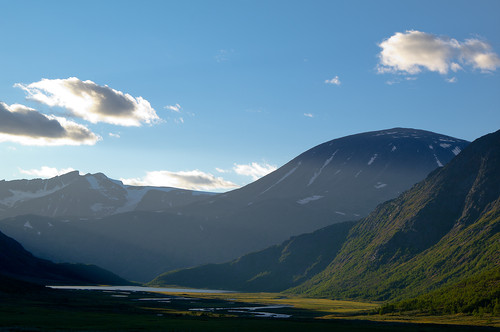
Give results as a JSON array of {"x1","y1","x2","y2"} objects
[{"x1": 14, "y1": 77, "x2": 160, "y2": 126}]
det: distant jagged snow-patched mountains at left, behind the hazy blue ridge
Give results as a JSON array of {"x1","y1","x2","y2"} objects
[{"x1": 0, "y1": 171, "x2": 213, "y2": 219}]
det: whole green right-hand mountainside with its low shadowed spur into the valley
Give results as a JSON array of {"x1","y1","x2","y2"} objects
[{"x1": 152, "y1": 131, "x2": 500, "y2": 313}]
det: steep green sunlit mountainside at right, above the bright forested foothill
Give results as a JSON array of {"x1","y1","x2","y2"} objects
[{"x1": 292, "y1": 131, "x2": 500, "y2": 300}]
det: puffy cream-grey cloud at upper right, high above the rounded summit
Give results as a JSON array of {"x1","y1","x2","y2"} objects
[{"x1": 378, "y1": 30, "x2": 500, "y2": 75}]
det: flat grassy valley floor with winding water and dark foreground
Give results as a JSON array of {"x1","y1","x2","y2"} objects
[{"x1": 0, "y1": 290, "x2": 500, "y2": 332}]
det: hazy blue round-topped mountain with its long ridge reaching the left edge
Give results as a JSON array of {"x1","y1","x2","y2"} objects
[{"x1": 0, "y1": 128, "x2": 468, "y2": 281}]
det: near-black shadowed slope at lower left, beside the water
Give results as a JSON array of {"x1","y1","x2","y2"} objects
[{"x1": 0, "y1": 228, "x2": 130, "y2": 287}]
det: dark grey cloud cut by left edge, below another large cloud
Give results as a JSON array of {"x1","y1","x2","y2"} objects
[{"x1": 0, "y1": 102, "x2": 101, "y2": 145}]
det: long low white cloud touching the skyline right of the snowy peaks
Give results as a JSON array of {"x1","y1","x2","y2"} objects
[{"x1": 120, "y1": 170, "x2": 238, "y2": 191}]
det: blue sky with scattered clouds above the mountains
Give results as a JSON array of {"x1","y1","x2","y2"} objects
[{"x1": 0, "y1": 0, "x2": 500, "y2": 192}]
